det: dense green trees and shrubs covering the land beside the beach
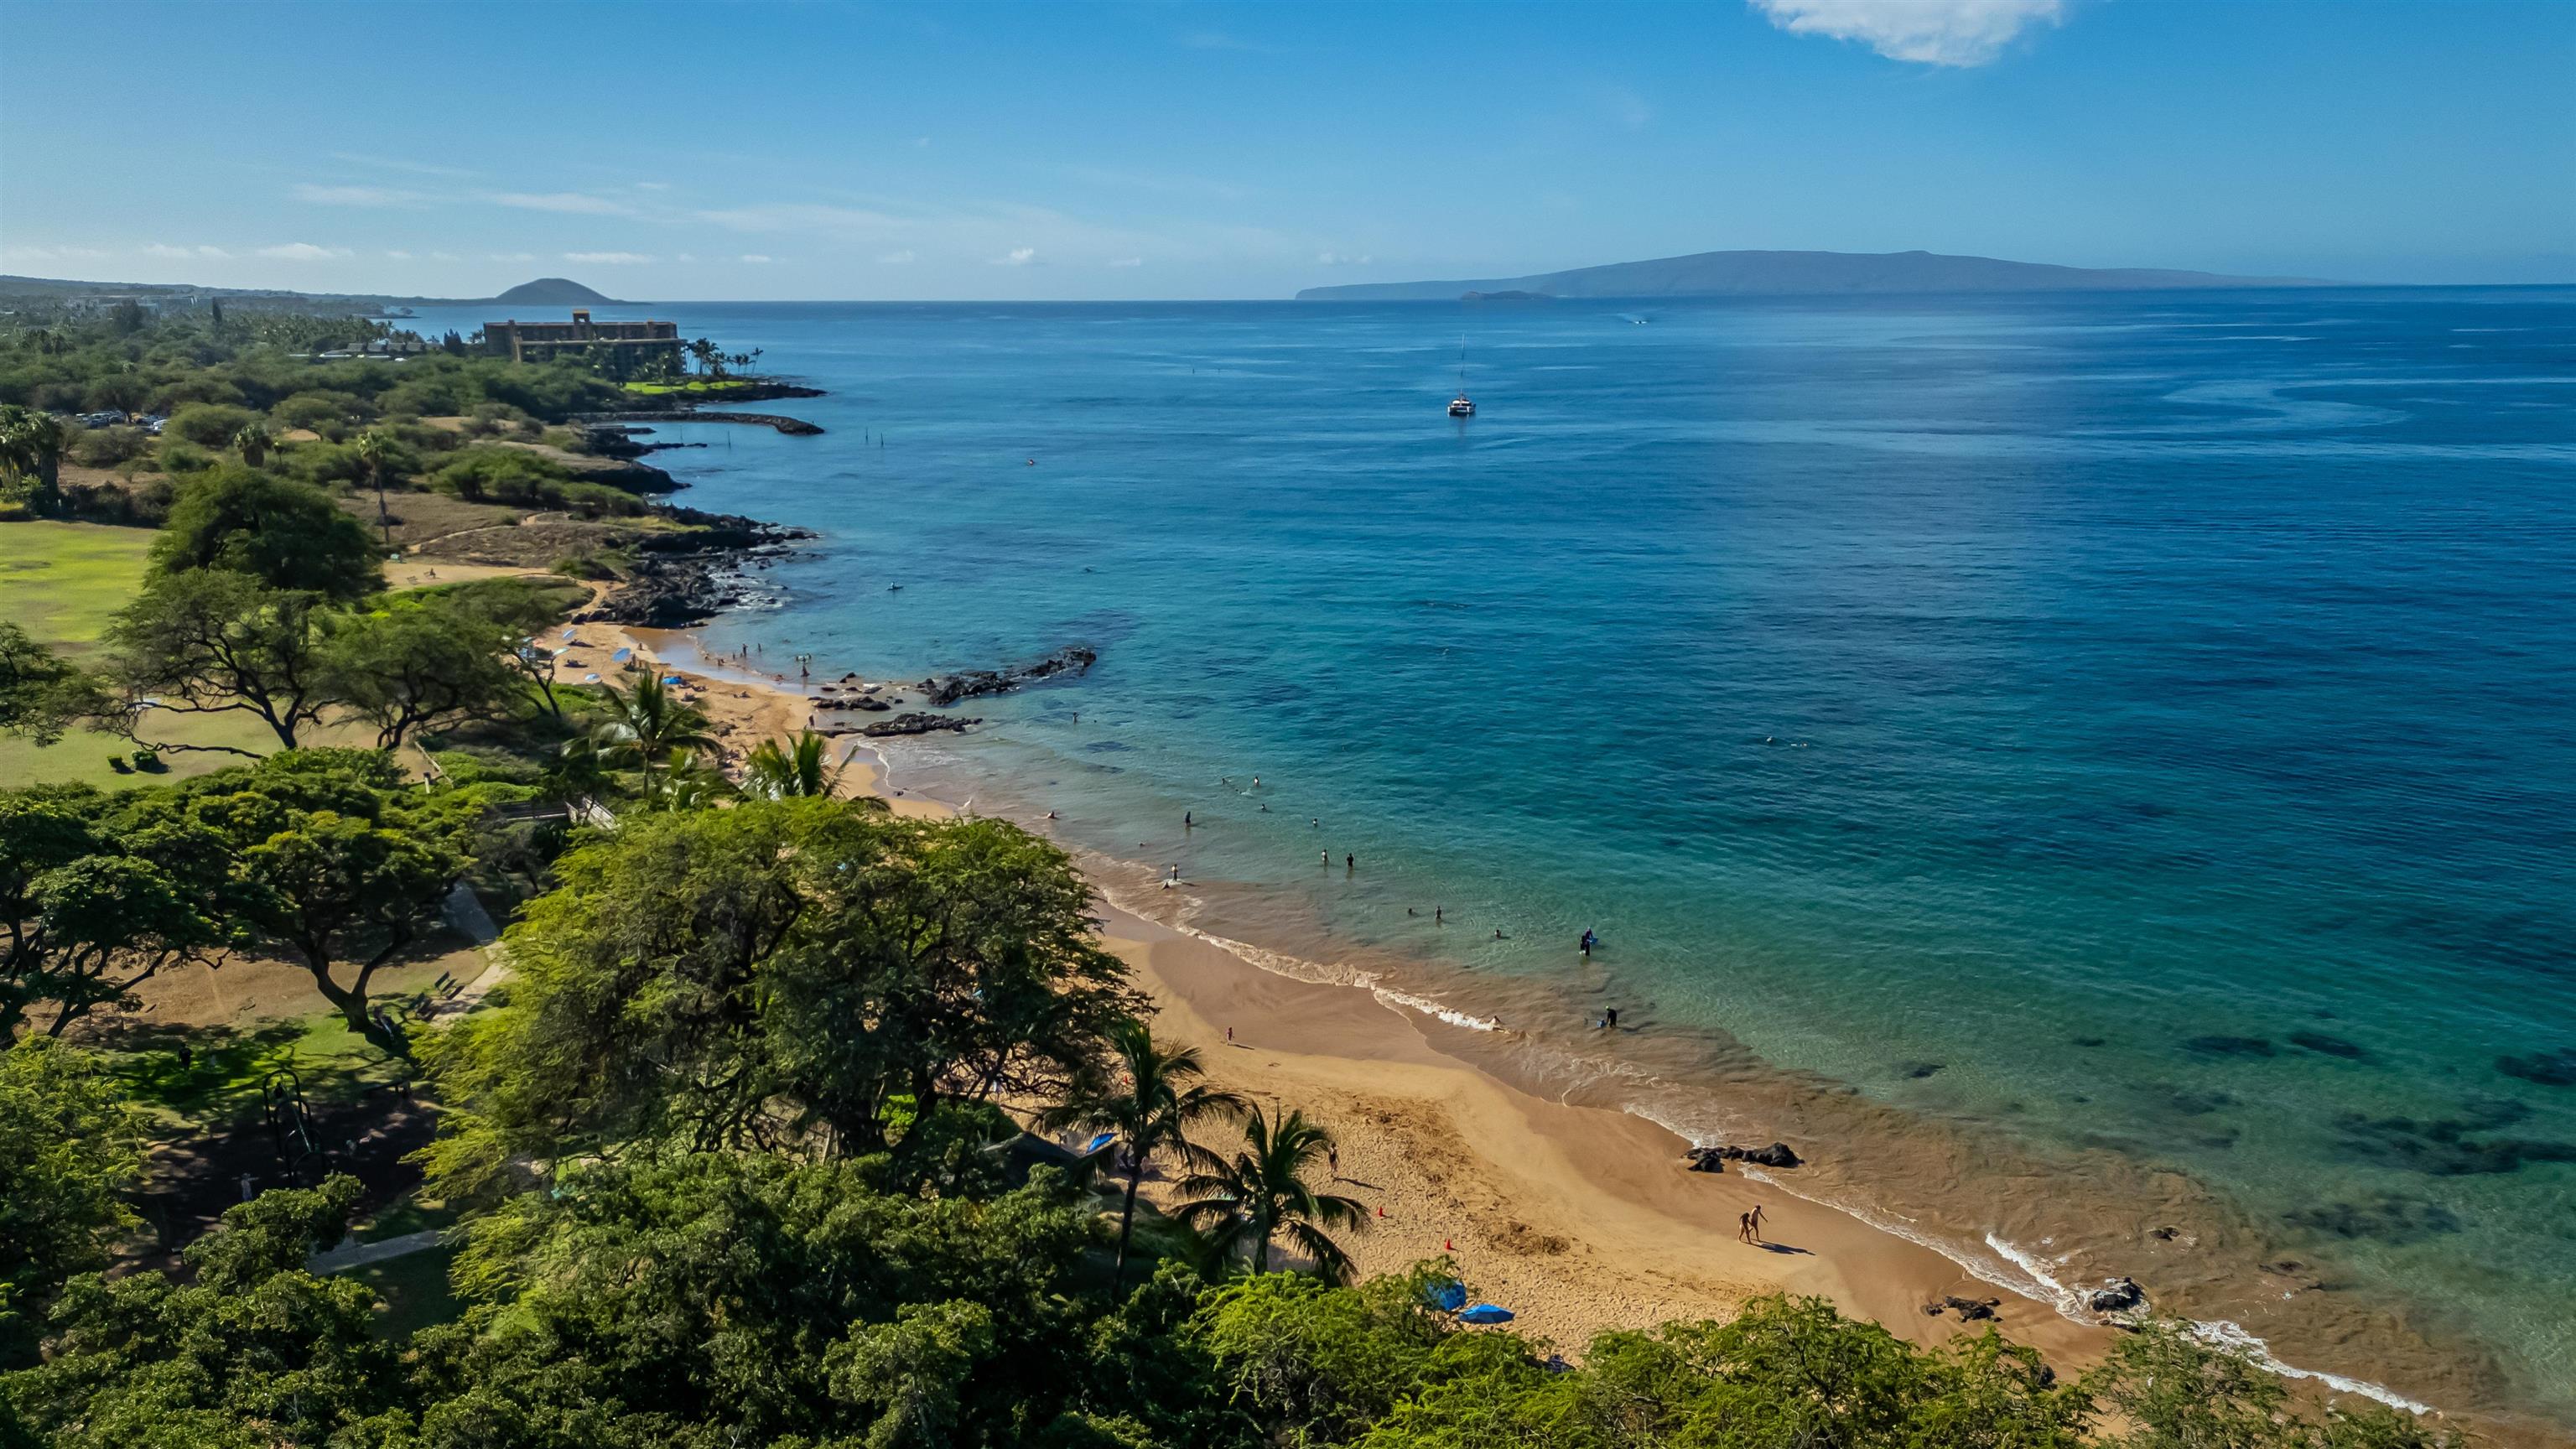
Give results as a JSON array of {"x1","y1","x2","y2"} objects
[{"x1": 0, "y1": 310, "x2": 2449, "y2": 1449}]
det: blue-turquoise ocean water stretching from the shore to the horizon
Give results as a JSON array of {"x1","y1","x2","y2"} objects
[{"x1": 422, "y1": 288, "x2": 2576, "y2": 1420}]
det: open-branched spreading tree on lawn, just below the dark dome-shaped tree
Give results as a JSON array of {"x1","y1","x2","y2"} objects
[{"x1": 106, "y1": 570, "x2": 330, "y2": 756}]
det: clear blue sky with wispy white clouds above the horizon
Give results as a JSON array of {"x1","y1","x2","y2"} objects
[{"x1": 0, "y1": 0, "x2": 2576, "y2": 299}]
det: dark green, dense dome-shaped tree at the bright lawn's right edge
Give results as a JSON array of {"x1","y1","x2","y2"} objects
[{"x1": 152, "y1": 467, "x2": 384, "y2": 598}]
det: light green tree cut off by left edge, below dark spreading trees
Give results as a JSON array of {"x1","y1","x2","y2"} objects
[{"x1": 0, "y1": 1036, "x2": 144, "y2": 1361}]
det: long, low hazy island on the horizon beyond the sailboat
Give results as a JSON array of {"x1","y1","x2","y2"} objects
[{"x1": 1296, "y1": 252, "x2": 2334, "y2": 302}]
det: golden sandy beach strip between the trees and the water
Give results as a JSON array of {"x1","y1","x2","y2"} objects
[{"x1": 557, "y1": 603, "x2": 2112, "y2": 1369}]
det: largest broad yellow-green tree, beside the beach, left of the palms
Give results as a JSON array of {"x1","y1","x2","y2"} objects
[{"x1": 425, "y1": 799, "x2": 1139, "y2": 1192}]
